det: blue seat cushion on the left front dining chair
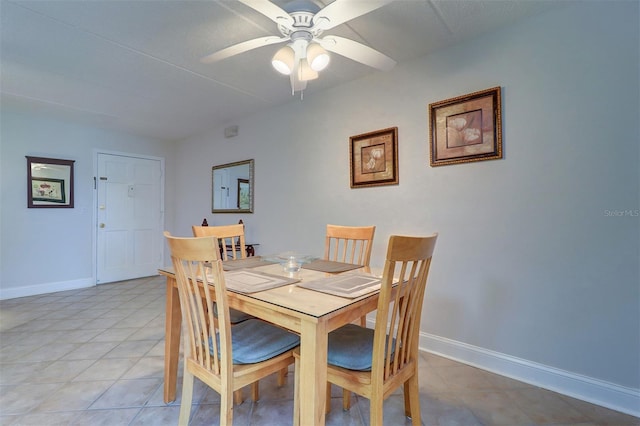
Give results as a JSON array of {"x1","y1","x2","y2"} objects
[{"x1": 209, "y1": 318, "x2": 300, "y2": 364}]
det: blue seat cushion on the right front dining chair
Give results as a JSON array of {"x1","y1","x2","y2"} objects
[{"x1": 327, "y1": 324, "x2": 395, "y2": 371}]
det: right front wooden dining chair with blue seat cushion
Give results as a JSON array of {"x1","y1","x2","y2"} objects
[{"x1": 294, "y1": 234, "x2": 437, "y2": 426}]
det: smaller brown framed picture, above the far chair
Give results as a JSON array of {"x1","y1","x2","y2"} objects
[{"x1": 349, "y1": 127, "x2": 399, "y2": 188}]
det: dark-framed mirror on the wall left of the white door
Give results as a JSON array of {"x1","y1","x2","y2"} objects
[{"x1": 27, "y1": 156, "x2": 74, "y2": 208}]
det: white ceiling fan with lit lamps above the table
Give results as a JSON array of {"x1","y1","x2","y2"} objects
[{"x1": 201, "y1": 0, "x2": 396, "y2": 94}]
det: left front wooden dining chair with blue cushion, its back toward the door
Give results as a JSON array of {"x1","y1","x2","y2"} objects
[{"x1": 165, "y1": 232, "x2": 300, "y2": 426}]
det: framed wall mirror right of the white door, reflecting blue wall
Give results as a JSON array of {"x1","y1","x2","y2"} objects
[{"x1": 211, "y1": 159, "x2": 254, "y2": 213}]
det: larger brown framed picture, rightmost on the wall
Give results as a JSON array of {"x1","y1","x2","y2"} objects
[{"x1": 429, "y1": 87, "x2": 502, "y2": 167}]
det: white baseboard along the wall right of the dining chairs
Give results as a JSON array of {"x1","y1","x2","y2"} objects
[{"x1": 419, "y1": 333, "x2": 640, "y2": 417}]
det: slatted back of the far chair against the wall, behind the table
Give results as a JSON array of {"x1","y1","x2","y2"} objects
[{"x1": 324, "y1": 225, "x2": 376, "y2": 266}]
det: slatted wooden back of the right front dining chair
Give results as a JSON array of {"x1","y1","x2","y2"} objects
[{"x1": 371, "y1": 234, "x2": 437, "y2": 382}]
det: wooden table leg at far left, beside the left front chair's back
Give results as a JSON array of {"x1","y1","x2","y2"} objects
[{"x1": 164, "y1": 277, "x2": 182, "y2": 404}]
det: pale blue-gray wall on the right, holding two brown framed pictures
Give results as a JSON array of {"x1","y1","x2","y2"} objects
[{"x1": 172, "y1": 2, "x2": 640, "y2": 410}]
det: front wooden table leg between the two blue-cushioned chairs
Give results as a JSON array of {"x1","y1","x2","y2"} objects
[{"x1": 299, "y1": 320, "x2": 327, "y2": 425}]
